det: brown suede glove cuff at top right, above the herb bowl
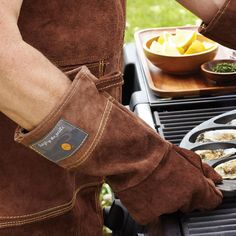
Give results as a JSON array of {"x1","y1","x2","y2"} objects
[{"x1": 199, "y1": 0, "x2": 236, "y2": 49}]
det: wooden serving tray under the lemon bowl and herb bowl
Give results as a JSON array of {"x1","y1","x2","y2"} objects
[{"x1": 135, "y1": 26, "x2": 236, "y2": 98}]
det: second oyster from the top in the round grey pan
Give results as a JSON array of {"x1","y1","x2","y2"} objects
[{"x1": 196, "y1": 129, "x2": 236, "y2": 143}]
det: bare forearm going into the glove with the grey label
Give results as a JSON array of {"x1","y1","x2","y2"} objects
[{"x1": 0, "y1": 34, "x2": 70, "y2": 130}]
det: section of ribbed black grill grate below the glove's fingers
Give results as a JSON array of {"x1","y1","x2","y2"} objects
[{"x1": 181, "y1": 198, "x2": 236, "y2": 236}]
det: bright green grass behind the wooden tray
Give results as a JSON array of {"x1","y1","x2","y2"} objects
[{"x1": 125, "y1": 0, "x2": 199, "y2": 42}]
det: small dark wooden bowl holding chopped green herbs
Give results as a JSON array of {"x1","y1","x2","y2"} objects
[{"x1": 201, "y1": 59, "x2": 236, "y2": 84}]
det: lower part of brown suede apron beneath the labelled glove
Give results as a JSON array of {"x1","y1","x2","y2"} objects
[{"x1": 0, "y1": 112, "x2": 102, "y2": 236}]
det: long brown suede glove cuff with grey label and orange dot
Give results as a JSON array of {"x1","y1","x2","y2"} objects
[{"x1": 15, "y1": 67, "x2": 171, "y2": 191}]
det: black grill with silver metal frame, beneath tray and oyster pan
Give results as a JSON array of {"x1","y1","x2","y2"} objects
[{"x1": 105, "y1": 44, "x2": 236, "y2": 236}]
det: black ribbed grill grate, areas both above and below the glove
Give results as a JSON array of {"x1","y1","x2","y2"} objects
[{"x1": 151, "y1": 99, "x2": 236, "y2": 236}]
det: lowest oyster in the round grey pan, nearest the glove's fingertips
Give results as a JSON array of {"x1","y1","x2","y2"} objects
[{"x1": 214, "y1": 159, "x2": 236, "y2": 179}]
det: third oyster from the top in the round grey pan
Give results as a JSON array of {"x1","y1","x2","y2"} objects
[{"x1": 195, "y1": 148, "x2": 236, "y2": 161}]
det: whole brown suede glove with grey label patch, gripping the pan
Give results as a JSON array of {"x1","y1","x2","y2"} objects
[{"x1": 15, "y1": 67, "x2": 222, "y2": 224}]
